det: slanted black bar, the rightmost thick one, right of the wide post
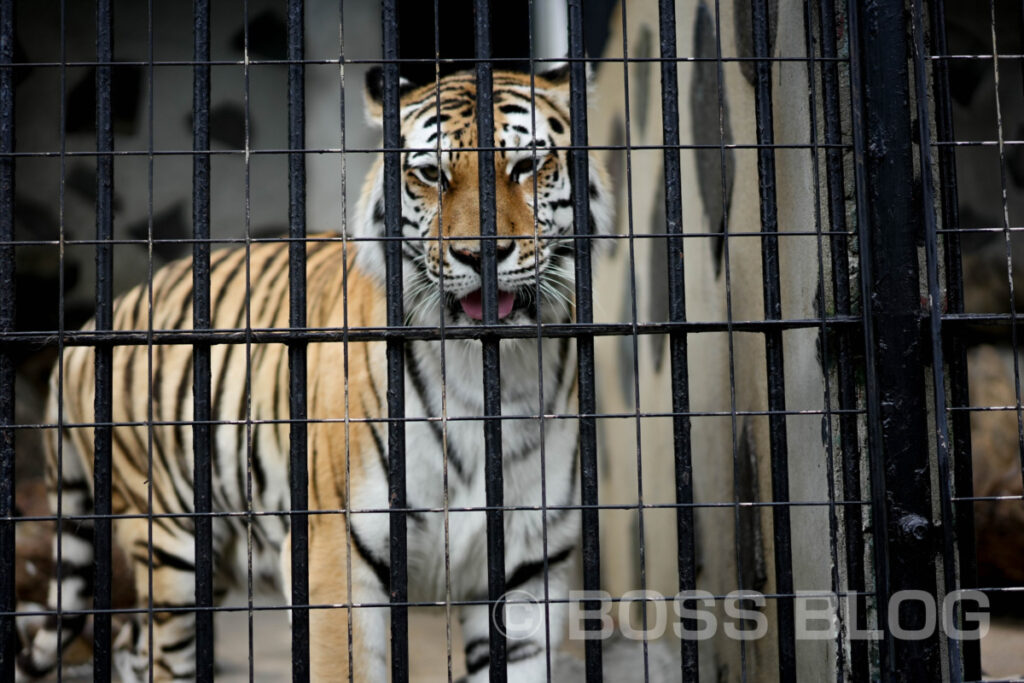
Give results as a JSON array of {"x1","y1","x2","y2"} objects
[{"x1": 928, "y1": 0, "x2": 981, "y2": 680}]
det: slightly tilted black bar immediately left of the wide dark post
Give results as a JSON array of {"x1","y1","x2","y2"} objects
[{"x1": 818, "y1": 0, "x2": 868, "y2": 681}]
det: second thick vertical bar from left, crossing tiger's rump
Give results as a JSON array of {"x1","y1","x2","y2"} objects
[{"x1": 92, "y1": 0, "x2": 114, "y2": 681}]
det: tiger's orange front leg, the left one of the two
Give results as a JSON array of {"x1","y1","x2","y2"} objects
[{"x1": 281, "y1": 514, "x2": 387, "y2": 683}]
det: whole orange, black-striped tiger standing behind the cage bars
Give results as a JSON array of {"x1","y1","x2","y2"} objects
[{"x1": 17, "y1": 66, "x2": 612, "y2": 683}]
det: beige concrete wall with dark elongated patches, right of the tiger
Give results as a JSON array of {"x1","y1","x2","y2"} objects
[{"x1": 591, "y1": 0, "x2": 843, "y2": 681}]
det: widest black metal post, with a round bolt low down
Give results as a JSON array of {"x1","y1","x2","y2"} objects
[{"x1": 849, "y1": 0, "x2": 941, "y2": 681}]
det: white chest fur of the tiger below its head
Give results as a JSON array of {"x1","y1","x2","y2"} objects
[{"x1": 352, "y1": 339, "x2": 578, "y2": 600}]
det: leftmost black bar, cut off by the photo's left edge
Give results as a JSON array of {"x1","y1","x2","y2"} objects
[{"x1": 0, "y1": 0, "x2": 17, "y2": 681}]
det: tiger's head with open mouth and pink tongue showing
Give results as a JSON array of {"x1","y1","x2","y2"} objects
[{"x1": 352, "y1": 68, "x2": 612, "y2": 326}]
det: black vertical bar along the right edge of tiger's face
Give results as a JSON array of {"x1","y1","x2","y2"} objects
[{"x1": 567, "y1": 0, "x2": 603, "y2": 683}]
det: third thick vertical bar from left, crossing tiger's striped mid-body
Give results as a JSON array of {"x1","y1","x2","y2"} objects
[{"x1": 193, "y1": 0, "x2": 213, "y2": 681}]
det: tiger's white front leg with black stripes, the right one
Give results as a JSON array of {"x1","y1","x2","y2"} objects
[{"x1": 462, "y1": 571, "x2": 568, "y2": 683}]
